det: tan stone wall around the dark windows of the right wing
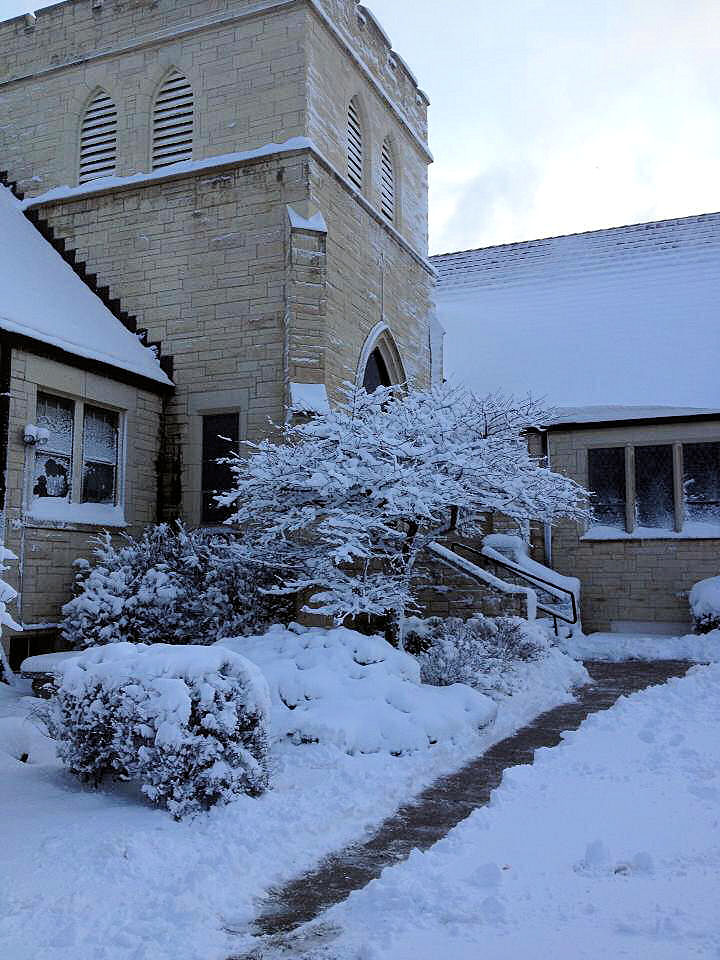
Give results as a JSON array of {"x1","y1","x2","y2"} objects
[{"x1": 549, "y1": 420, "x2": 720, "y2": 631}]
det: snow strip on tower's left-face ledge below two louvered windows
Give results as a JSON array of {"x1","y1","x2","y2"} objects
[{"x1": 21, "y1": 137, "x2": 316, "y2": 210}]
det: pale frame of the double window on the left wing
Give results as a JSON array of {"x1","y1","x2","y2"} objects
[{"x1": 29, "y1": 384, "x2": 128, "y2": 526}]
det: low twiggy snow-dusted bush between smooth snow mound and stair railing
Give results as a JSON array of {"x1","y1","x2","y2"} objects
[{"x1": 407, "y1": 615, "x2": 550, "y2": 692}]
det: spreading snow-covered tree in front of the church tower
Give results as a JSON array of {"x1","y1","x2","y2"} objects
[{"x1": 219, "y1": 385, "x2": 588, "y2": 633}]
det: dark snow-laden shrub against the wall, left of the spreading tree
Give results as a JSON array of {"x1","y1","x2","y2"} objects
[{"x1": 62, "y1": 524, "x2": 294, "y2": 649}]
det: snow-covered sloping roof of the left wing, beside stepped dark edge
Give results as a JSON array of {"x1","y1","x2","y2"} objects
[{"x1": 0, "y1": 187, "x2": 172, "y2": 385}]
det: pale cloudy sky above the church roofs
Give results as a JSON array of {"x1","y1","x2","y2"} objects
[{"x1": 0, "y1": 0, "x2": 720, "y2": 253}]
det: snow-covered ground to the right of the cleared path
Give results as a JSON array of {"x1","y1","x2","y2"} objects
[{"x1": 296, "y1": 664, "x2": 720, "y2": 960}]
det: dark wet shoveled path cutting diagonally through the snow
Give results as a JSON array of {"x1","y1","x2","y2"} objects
[{"x1": 235, "y1": 660, "x2": 691, "y2": 958}]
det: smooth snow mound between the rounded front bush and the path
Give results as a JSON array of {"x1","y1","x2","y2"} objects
[{"x1": 220, "y1": 624, "x2": 497, "y2": 755}]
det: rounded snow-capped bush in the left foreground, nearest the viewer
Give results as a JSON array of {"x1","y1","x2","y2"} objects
[{"x1": 43, "y1": 643, "x2": 269, "y2": 819}]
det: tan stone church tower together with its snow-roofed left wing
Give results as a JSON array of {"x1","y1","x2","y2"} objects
[{"x1": 0, "y1": 0, "x2": 441, "y2": 662}]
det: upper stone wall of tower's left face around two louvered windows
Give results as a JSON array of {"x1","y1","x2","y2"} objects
[{"x1": 0, "y1": 0, "x2": 306, "y2": 196}]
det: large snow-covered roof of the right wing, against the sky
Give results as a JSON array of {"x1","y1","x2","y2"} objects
[{"x1": 431, "y1": 213, "x2": 720, "y2": 419}]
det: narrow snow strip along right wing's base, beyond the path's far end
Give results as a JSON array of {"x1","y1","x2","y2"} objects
[{"x1": 559, "y1": 630, "x2": 720, "y2": 663}]
